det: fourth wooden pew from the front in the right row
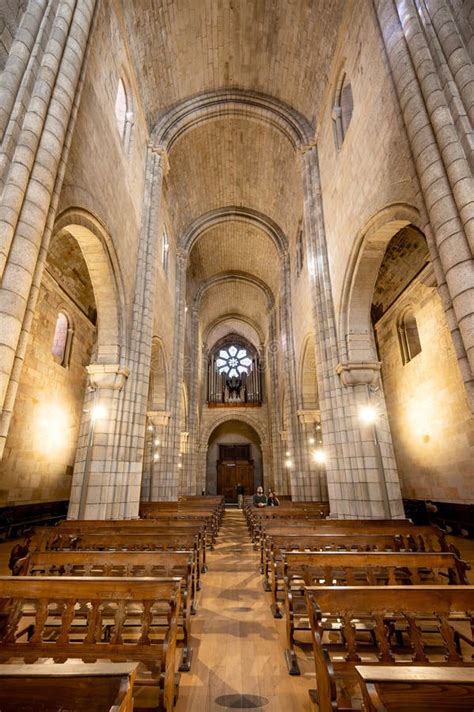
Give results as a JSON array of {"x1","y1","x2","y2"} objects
[{"x1": 260, "y1": 519, "x2": 452, "y2": 590}]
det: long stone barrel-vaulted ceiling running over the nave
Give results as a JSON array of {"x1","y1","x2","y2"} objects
[{"x1": 120, "y1": 0, "x2": 344, "y2": 344}]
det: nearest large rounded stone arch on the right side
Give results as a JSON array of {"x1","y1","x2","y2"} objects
[{"x1": 339, "y1": 203, "x2": 422, "y2": 363}]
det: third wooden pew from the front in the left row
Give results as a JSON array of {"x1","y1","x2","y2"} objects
[{"x1": 13, "y1": 551, "x2": 196, "y2": 672}]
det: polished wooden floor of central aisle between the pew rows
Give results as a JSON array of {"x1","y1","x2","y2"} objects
[{"x1": 176, "y1": 510, "x2": 315, "y2": 712}]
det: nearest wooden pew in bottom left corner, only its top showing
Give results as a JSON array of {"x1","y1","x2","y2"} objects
[{"x1": 0, "y1": 663, "x2": 137, "y2": 712}]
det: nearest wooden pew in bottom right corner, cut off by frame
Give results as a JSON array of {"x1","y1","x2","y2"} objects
[{"x1": 356, "y1": 665, "x2": 474, "y2": 712}]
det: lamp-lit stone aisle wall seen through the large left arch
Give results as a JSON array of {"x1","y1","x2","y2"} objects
[{"x1": 0, "y1": 272, "x2": 95, "y2": 506}]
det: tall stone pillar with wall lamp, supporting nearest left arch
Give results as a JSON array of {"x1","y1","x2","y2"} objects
[{"x1": 68, "y1": 145, "x2": 167, "y2": 519}]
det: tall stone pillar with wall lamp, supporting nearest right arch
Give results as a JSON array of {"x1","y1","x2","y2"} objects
[{"x1": 302, "y1": 145, "x2": 404, "y2": 519}]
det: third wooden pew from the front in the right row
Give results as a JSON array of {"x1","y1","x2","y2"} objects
[{"x1": 272, "y1": 551, "x2": 469, "y2": 675}]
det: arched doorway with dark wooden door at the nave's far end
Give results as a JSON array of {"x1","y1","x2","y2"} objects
[{"x1": 206, "y1": 420, "x2": 263, "y2": 504}]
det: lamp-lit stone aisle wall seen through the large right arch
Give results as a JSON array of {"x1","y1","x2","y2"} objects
[{"x1": 376, "y1": 270, "x2": 474, "y2": 503}]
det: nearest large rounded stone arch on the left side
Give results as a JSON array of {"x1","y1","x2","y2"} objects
[{"x1": 53, "y1": 208, "x2": 125, "y2": 364}]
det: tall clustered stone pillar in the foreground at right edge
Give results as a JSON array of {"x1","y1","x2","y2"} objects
[{"x1": 374, "y1": 0, "x2": 474, "y2": 405}]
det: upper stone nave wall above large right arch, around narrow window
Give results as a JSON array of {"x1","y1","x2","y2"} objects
[{"x1": 315, "y1": 0, "x2": 419, "y2": 318}]
